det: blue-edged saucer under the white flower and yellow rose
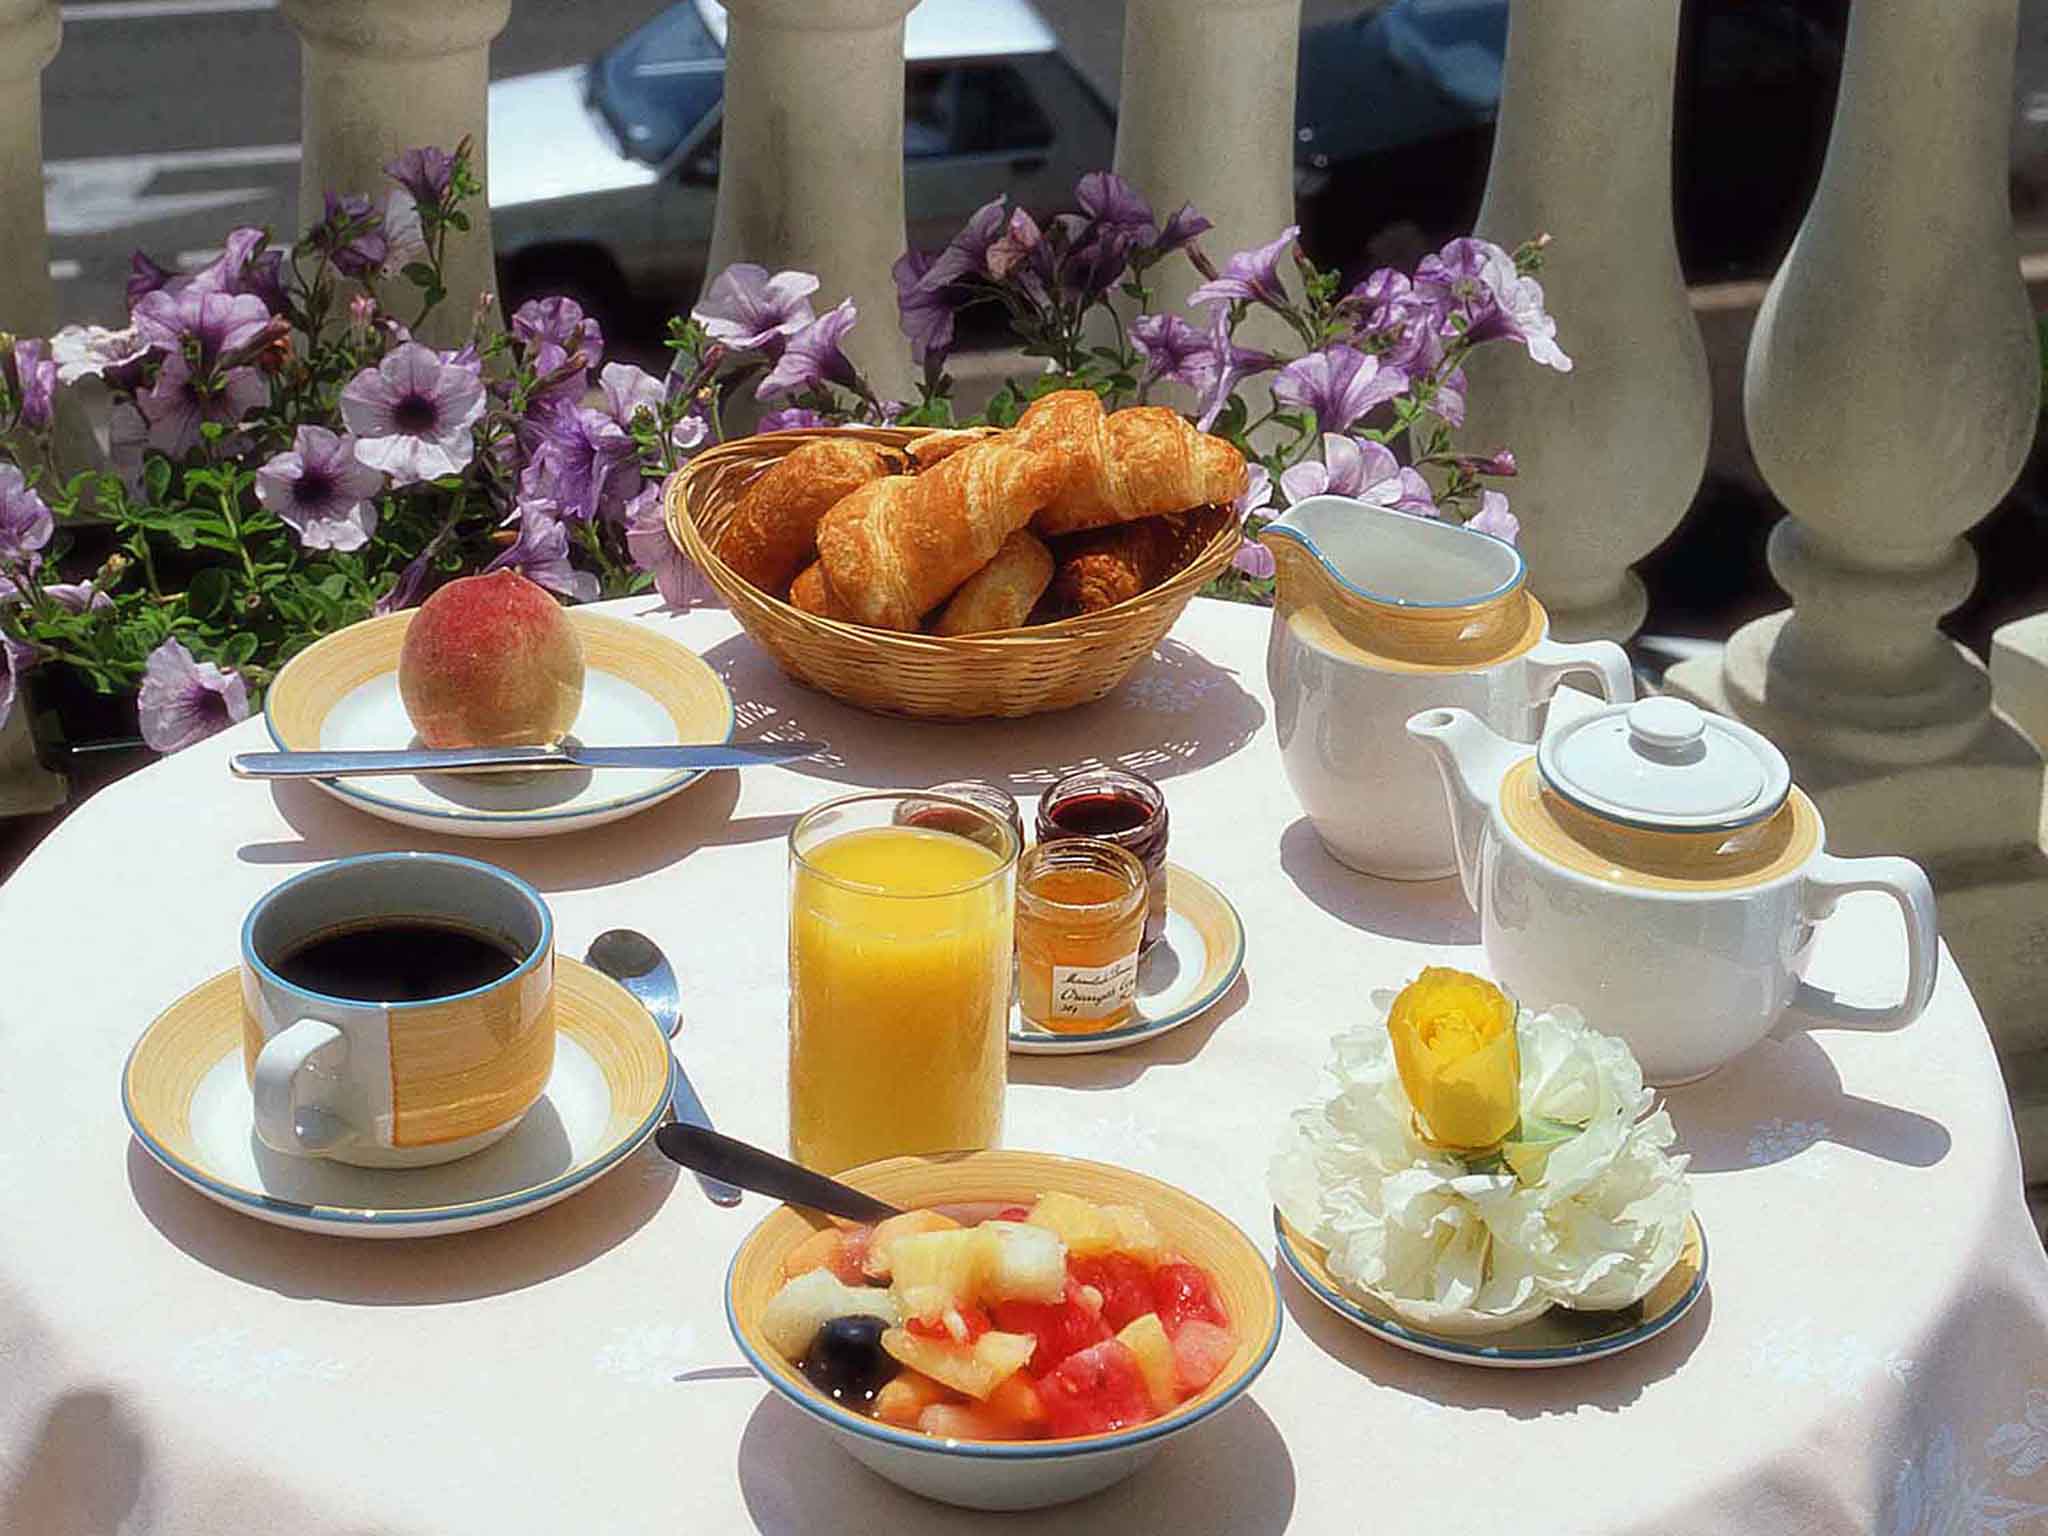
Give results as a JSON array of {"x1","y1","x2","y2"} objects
[{"x1": 1274, "y1": 1210, "x2": 1706, "y2": 1370}]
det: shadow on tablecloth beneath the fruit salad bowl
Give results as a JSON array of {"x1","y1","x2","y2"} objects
[{"x1": 739, "y1": 1386, "x2": 1294, "y2": 1536}]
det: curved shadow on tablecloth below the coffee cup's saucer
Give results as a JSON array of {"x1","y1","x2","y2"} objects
[{"x1": 123, "y1": 1141, "x2": 680, "y2": 1302}]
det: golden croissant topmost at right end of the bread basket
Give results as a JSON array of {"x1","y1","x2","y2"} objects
[{"x1": 1012, "y1": 389, "x2": 1245, "y2": 537}]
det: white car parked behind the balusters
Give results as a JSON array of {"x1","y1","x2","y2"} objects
[{"x1": 489, "y1": 0, "x2": 1114, "y2": 335}]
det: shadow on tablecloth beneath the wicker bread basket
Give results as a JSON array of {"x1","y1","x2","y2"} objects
[{"x1": 705, "y1": 635, "x2": 1266, "y2": 795}]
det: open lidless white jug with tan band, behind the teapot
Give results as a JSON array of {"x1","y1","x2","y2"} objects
[{"x1": 1260, "y1": 496, "x2": 1634, "y2": 881}]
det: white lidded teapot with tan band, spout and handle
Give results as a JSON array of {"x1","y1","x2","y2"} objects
[{"x1": 1407, "y1": 698, "x2": 1937, "y2": 1085}]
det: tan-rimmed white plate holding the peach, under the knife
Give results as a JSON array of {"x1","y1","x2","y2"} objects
[{"x1": 262, "y1": 608, "x2": 733, "y2": 838}]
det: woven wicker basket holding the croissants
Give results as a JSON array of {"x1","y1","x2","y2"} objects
[{"x1": 664, "y1": 428, "x2": 1239, "y2": 721}]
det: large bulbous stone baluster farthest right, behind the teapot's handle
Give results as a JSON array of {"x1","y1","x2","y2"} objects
[{"x1": 1681, "y1": 0, "x2": 2040, "y2": 764}]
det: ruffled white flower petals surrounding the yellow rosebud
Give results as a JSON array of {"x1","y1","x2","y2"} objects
[{"x1": 1270, "y1": 991, "x2": 1692, "y2": 1335}]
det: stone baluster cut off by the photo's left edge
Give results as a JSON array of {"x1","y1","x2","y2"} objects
[{"x1": 0, "y1": 0, "x2": 63, "y2": 817}]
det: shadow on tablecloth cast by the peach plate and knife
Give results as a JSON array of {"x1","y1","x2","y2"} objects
[{"x1": 236, "y1": 772, "x2": 797, "y2": 891}]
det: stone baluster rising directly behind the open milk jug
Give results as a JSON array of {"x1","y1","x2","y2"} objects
[{"x1": 1460, "y1": 0, "x2": 1712, "y2": 639}]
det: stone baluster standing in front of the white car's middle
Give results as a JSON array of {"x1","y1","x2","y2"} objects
[{"x1": 707, "y1": 0, "x2": 918, "y2": 399}]
